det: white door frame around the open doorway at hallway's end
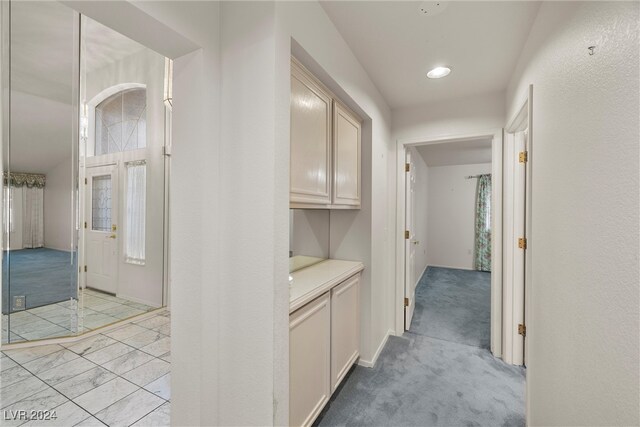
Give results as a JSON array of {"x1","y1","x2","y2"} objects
[{"x1": 394, "y1": 129, "x2": 503, "y2": 357}]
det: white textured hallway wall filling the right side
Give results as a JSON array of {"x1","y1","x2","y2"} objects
[{"x1": 506, "y1": 2, "x2": 640, "y2": 425}]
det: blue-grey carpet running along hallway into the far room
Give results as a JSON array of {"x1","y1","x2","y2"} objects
[{"x1": 315, "y1": 267, "x2": 525, "y2": 426}]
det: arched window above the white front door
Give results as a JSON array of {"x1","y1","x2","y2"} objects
[{"x1": 94, "y1": 88, "x2": 147, "y2": 156}]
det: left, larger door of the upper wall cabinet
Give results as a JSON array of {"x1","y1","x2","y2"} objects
[{"x1": 290, "y1": 62, "x2": 331, "y2": 205}]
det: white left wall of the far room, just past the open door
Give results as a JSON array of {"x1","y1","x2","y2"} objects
[{"x1": 409, "y1": 147, "x2": 430, "y2": 283}]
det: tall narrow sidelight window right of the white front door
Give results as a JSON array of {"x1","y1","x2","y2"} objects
[{"x1": 125, "y1": 161, "x2": 147, "y2": 265}]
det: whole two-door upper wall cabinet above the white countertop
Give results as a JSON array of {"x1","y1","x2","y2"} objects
[{"x1": 289, "y1": 58, "x2": 361, "y2": 209}]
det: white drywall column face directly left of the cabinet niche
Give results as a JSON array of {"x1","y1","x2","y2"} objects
[{"x1": 218, "y1": 2, "x2": 289, "y2": 425}]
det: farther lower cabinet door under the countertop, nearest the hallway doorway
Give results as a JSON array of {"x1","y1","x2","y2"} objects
[{"x1": 331, "y1": 274, "x2": 360, "y2": 392}]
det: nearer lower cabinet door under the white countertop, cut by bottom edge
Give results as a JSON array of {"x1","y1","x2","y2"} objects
[{"x1": 289, "y1": 292, "x2": 331, "y2": 426}]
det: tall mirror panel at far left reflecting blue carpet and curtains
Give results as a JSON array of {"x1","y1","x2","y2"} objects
[{"x1": 2, "y1": 2, "x2": 78, "y2": 342}]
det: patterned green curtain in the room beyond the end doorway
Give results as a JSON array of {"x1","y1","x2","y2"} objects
[{"x1": 474, "y1": 174, "x2": 491, "y2": 271}]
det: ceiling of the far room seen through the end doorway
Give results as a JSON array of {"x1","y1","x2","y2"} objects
[{"x1": 416, "y1": 138, "x2": 491, "y2": 167}]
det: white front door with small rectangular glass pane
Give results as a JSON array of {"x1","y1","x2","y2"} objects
[{"x1": 85, "y1": 165, "x2": 118, "y2": 294}]
